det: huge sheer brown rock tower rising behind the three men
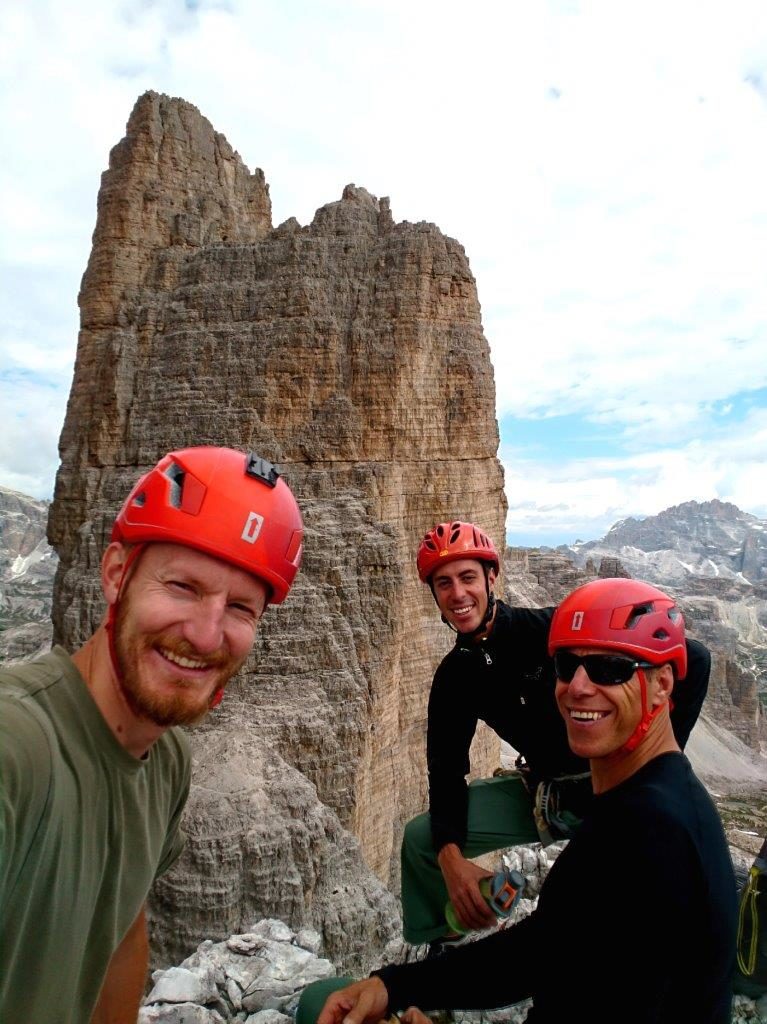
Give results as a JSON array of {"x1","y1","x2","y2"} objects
[{"x1": 49, "y1": 93, "x2": 506, "y2": 957}]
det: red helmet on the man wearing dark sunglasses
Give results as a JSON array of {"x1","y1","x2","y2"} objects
[{"x1": 549, "y1": 579, "x2": 687, "y2": 679}]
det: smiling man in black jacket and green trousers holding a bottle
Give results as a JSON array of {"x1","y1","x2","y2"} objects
[{"x1": 401, "y1": 521, "x2": 711, "y2": 952}]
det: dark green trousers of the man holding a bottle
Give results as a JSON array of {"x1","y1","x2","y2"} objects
[{"x1": 401, "y1": 772, "x2": 539, "y2": 945}]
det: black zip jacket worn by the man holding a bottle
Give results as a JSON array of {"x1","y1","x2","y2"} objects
[{"x1": 426, "y1": 601, "x2": 711, "y2": 850}]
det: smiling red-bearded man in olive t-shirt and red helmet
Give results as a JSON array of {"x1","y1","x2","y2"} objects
[{"x1": 0, "y1": 447, "x2": 303, "y2": 1024}]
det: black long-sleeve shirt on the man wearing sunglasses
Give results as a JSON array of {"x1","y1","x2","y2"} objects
[{"x1": 375, "y1": 753, "x2": 737, "y2": 1024}]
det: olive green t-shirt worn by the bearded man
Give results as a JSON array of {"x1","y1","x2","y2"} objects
[{"x1": 0, "y1": 647, "x2": 189, "y2": 1024}]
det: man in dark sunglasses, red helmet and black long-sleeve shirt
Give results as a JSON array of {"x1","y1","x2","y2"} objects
[{"x1": 317, "y1": 580, "x2": 736, "y2": 1024}]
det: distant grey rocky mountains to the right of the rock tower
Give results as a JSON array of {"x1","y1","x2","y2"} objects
[{"x1": 504, "y1": 501, "x2": 767, "y2": 765}]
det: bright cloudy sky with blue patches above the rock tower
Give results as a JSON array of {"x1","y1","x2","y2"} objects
[{"x1": 0, "y1": 0, "x2": 767, "y2": 544}]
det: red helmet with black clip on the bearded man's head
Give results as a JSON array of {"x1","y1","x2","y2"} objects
[{"x1": 112, "y1": 447, "x2": 303, "y2": 604}]
